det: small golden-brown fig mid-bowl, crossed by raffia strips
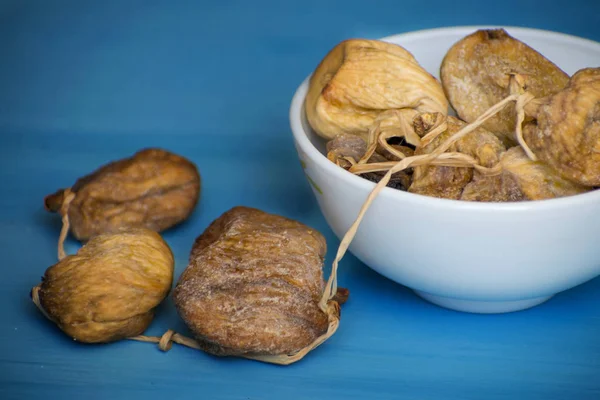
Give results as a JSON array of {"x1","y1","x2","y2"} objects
[{"x1": 408, "y1": 115, "x2": 505, "y2": 200}]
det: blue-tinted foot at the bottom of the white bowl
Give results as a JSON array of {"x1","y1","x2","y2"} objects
[{"x1": 414, "y1": 290, "x2": 553, "y2": 314}]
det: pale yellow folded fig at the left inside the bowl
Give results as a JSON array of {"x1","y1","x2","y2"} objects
[{"x1": 305, "y1": 39, "x2": 448, "y2": 139}]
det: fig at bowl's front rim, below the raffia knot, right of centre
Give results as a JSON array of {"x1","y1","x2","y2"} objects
[{"x1": 461, "y1": 146, "x2": 590, "y2": 202}]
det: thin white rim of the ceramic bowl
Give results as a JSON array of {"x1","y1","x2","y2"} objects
[{"x1": 289, "y1": 25, "x2": 600, "y2": 212}]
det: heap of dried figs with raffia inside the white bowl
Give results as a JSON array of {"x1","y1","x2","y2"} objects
[{"x1": 305, "y1": 29, "x2": 600, "y2": 202}]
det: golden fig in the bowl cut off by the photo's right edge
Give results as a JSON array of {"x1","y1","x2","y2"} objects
[{"x1": 523, "y1": 68, "x2": 600, "y2": 187}]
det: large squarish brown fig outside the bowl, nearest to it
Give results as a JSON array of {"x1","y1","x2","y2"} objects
[{"x1": 173, "y1": 207, "x2": 336, "y2": 356}]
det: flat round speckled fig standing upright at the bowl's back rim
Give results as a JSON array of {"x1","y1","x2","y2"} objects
[{"x1": 440, "y1": 29, "x2": 569, "y2": 144}]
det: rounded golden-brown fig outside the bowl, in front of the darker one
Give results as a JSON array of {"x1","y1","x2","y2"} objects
[{"x1": 39, "y1": 229, "x2": 174, "y2": 343}]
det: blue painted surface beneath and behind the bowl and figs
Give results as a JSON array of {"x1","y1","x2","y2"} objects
[{"x1": 0, "y1": 0, "x2": 600, "y2": 400}]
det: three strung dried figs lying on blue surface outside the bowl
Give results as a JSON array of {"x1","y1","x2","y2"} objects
[{"x1": 31, "y1": 149, "x2": 348, "y2": 364}]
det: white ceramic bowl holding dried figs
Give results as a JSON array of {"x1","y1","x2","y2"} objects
[{"x1": 290, "y1": 26, "x2": 600, "y2": 313}]
